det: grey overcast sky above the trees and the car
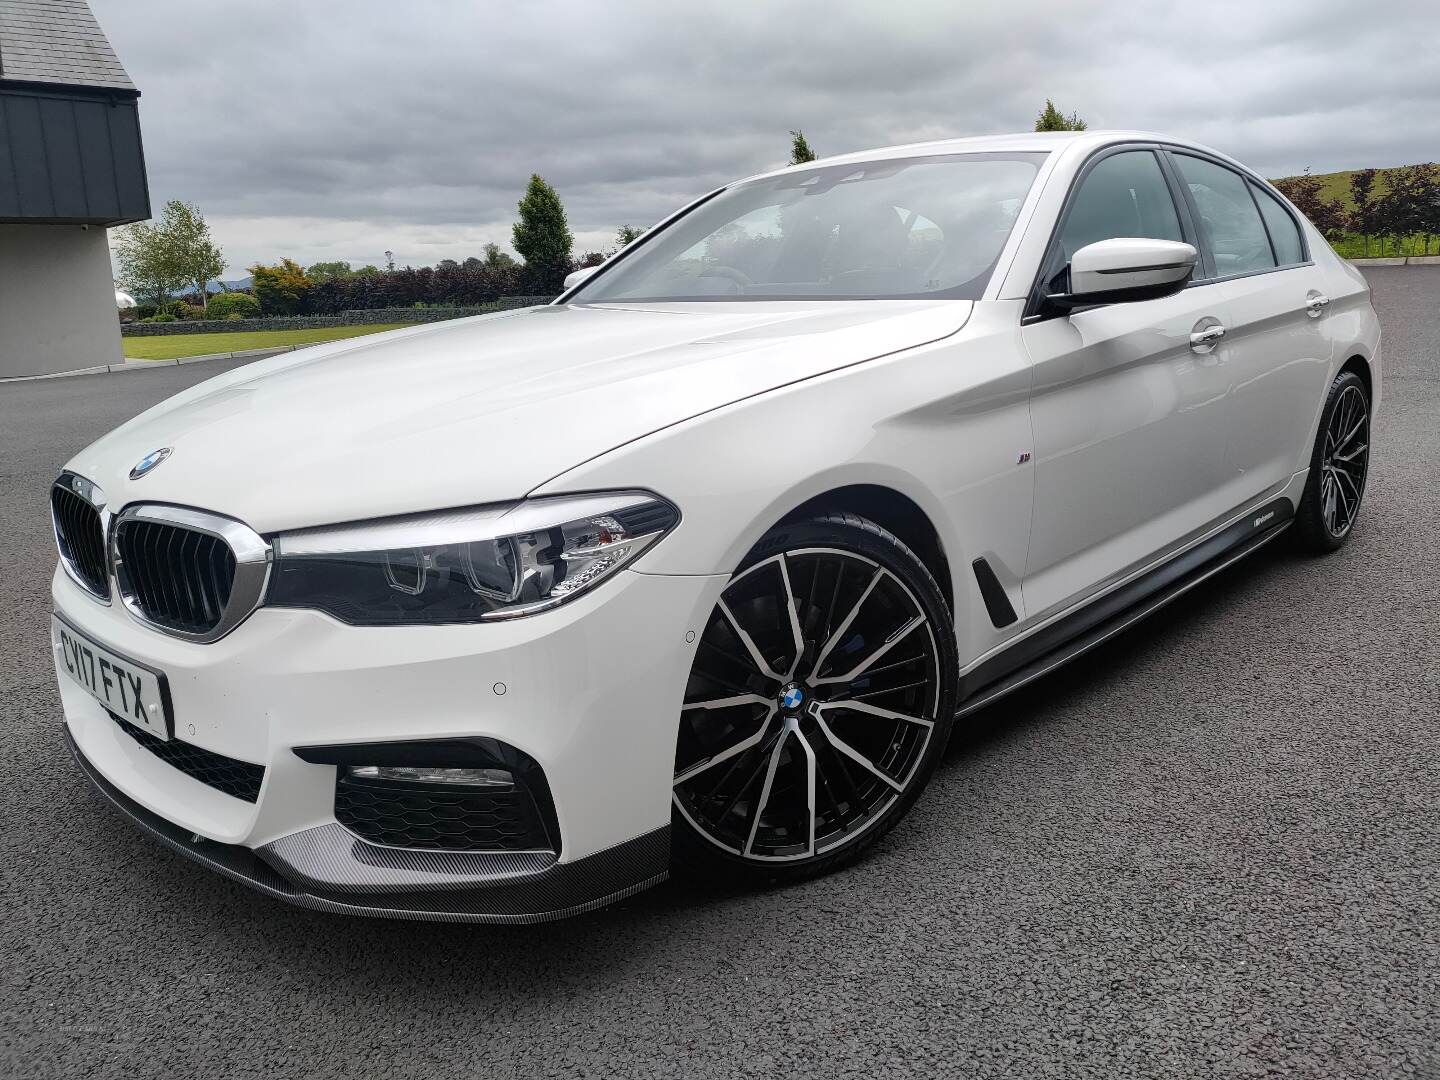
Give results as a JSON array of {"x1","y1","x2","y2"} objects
[{"x1": 91, "y1": 0, "x2": 1440, "y2": 278}]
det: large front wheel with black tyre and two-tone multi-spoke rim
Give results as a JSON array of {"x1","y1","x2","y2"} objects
[{"x1": 671, "y1": 514, "x2": 958, "y2": 886}]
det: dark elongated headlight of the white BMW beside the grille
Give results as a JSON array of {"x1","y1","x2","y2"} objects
[{"x1": 266, "y1": 491, "x2": 680, "y2": 626}]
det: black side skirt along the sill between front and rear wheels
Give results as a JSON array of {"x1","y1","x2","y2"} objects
[{"x1": 956, "y1": 498, "x2": 1295, "y2": 717}]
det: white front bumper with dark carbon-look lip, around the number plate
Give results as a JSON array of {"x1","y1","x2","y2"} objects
[{"x1": 52, "y1": 570, "x2": 724, "y2": 923}]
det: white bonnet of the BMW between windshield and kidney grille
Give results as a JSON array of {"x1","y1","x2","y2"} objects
[{"x1": 69, "y1": 300, "x2": 972, "y2": 533}]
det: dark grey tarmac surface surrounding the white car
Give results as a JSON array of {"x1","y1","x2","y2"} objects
[{"x1": 0, "y1": 268, "x2": 1440, "y2": 1080}]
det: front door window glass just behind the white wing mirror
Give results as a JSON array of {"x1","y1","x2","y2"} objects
[{"x1": 1054, "y1": 150, "x2": 1185, "y2": 271}]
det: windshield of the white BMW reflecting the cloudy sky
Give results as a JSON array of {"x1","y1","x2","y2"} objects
[{"x1": 570, "y1": 154, "x2": 1044, "y2": 304}]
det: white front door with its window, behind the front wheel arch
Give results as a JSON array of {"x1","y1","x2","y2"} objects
[{"x1": 1021, "y1": 145, "x2": 1228, "y2": 615}]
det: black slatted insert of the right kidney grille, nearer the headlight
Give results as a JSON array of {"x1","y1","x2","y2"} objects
[{"x1": 115, "y1": 521, "x2": 235, "y2": 634}]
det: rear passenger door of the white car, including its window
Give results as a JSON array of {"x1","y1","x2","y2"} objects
[{"x1": 1171, "y1": 150, "x2": 1333, "y2": 504}]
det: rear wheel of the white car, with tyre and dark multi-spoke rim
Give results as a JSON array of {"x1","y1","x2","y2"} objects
[{"x1": 1293, "y1": 372, "x2": 1369, "y2": 554}]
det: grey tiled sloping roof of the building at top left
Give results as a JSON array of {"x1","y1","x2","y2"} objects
[{"x1": 0, "y1": 0, "x2": 135, "y2": 91}]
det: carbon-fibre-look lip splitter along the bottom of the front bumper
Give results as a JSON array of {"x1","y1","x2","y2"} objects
[{"x1": 65, "y1": 727, "x2": 670, "y2": 923}]
